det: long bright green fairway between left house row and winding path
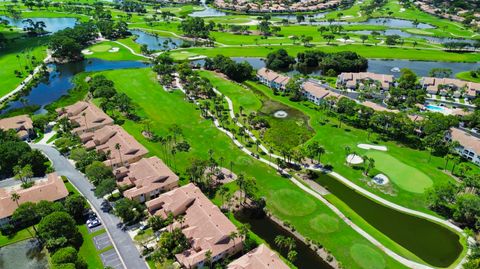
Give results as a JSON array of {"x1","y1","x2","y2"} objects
[{"x1": 96, "y1": 69, "x2": 404, "y2": 268}]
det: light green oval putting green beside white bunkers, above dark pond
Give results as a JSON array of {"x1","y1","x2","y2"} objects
[{"x1": 366, "y1": 150, "x2": 433, "y2": 193}]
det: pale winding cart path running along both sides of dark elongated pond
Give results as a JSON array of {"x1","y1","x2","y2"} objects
[{"x1": 175, "y1": 76, "x2": 466, "y2": 269}]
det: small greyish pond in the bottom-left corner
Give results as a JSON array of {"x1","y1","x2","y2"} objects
[{"x1": 0, "y1": 240, "x2": 48, "y2": 269}]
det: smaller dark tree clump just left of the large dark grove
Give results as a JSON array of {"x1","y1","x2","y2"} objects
[{"x1": 203, "y1": 55, "x2": 253, "y2": 82}]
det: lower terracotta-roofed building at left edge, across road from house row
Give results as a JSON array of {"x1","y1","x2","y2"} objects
[{"x1": 0, "y1": 173, "x2": 68, "y2": 226}]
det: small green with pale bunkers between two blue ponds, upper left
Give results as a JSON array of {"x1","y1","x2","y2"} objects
[{"x1": 85, "y1": 41, "x2": 146, "y2": 61}]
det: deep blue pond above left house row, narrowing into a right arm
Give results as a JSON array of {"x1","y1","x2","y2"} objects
[{"x1": 0, "y1": 59, "x2": 146, "y2": 114}]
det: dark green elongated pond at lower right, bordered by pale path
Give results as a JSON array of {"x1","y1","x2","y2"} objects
[{"x1": 316, "y1": 174, "x2": 463, "y2": 267}]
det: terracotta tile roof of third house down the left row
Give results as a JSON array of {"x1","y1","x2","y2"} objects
[{"x1": 120, "y1": 157, "x2": 179, "y2": 199}]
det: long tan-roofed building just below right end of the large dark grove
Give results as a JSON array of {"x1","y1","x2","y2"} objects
[{"x1": 337, "y1": 72, "x2": 394, "y2": 91}]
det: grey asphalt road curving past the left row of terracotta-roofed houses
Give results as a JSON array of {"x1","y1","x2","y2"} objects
[{"x1": 30, "y1": 144, "x2": 148, "y2": 269}]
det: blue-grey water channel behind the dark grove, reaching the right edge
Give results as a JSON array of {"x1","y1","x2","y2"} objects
[{"x1": 194, "y1": 57, "x2": 480, "y2": 77}]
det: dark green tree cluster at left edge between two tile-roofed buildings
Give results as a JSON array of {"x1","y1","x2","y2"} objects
[{"x1": 0, "y1": 130, "x2": 48, "y2": 178}]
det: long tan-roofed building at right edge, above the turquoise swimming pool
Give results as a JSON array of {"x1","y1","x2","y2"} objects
[{"x1": 420, "y1": 77, "x2": 480, "y2": 99}]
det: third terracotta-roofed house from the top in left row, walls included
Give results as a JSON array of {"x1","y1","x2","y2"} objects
[{"x1": 114, "y1": 157, "x2": 179, "y2": 203}]
